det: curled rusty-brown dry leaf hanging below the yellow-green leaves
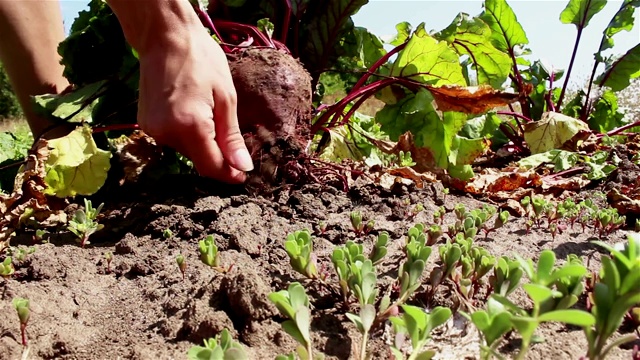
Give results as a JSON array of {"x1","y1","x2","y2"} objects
[{"x1": 427, "y1": 86, "x2": 520, "y2": 115}]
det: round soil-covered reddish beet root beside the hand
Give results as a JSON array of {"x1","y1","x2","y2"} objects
[{"x1": 229, "y1": 48, "x2": 313, "y2": 137}]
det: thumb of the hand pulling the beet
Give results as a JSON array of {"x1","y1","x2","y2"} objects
[{"x1": 213, "y1": 91, "x2": 253, "y2": 171}]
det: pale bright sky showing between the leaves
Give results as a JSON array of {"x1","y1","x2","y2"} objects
[{"x1": 60, "y1": 0, "x2": 640, "y2": 84}]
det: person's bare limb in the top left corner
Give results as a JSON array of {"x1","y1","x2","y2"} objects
[{"x1": 0, "y1": 0, "x2": 68, "y2": 137}]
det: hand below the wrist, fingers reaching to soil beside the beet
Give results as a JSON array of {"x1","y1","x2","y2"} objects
[{"x1": 138, "y1": 21, "x2": 253, "y2": 183}]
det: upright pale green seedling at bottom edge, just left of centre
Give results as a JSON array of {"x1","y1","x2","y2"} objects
[{"x1": 269, "y1": 282, "x2": 317, "y2": 359}]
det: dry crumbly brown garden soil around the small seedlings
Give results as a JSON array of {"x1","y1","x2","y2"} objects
[{"x1": 0, "y1": 172, "x2": 633, "y2": 359}]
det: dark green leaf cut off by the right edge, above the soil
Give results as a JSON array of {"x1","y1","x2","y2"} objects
[{"x1": 596, "y1": 44, "x2": 640, "y2": 92}]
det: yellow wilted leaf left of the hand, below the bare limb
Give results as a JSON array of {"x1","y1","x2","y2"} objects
[{"x1": 44, "y1": 125, "x2": 111, "y2": 198}]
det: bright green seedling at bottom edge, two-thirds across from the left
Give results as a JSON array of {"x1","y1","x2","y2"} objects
[{"x1": 389, "y1": 305, "x2": 451, "y2": 360}]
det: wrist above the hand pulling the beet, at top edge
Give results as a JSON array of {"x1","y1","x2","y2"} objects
[{"x1": 107, "y1": 0, "x2": 204, "y2": 55}]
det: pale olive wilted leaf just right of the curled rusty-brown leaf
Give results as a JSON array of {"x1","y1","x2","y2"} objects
[{"x1": 524, "y1": 112, "x2": 589, "y2": 154}]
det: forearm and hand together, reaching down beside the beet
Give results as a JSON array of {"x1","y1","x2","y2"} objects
[{"x1": 107, "y1": 0, "x2": 253, "y2": 183}]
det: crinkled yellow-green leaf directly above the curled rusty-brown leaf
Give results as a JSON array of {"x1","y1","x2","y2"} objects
[{"x1": 434, "y1": 13, "x2": 512, "y2": 89}]
